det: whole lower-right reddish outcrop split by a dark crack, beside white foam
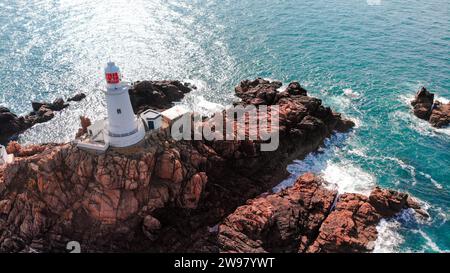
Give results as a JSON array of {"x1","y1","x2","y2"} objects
[{"x1": 218, "y1": 173, "x2": 424, "y2": 253}]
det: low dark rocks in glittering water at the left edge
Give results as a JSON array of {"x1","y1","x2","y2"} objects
[{"x1": 0, "y1": 93, "x2": 85, "y2": 143}]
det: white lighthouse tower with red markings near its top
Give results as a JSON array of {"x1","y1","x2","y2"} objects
[{"x1": 105, "y1": 62, "x2": 145, "y2": 147}]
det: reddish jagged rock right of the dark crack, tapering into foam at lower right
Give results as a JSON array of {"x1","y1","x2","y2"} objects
[{"x1": 307, "y1": 187, "x2": 422, "y2": 252}]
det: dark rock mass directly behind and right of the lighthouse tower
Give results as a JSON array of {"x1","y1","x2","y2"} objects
[{"x1": 129, "y1": 81, "x2": 196, "y2": 113}]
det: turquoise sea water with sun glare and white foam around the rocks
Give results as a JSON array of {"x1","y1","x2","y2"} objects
[{"x1": 0, "y1": 0, "x2": 450, "y2": 252}]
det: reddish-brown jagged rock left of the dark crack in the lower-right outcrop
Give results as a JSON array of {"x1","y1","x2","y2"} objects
[{"x1": 218, "y1": 174, "x2": 337, "y2": 253}]
